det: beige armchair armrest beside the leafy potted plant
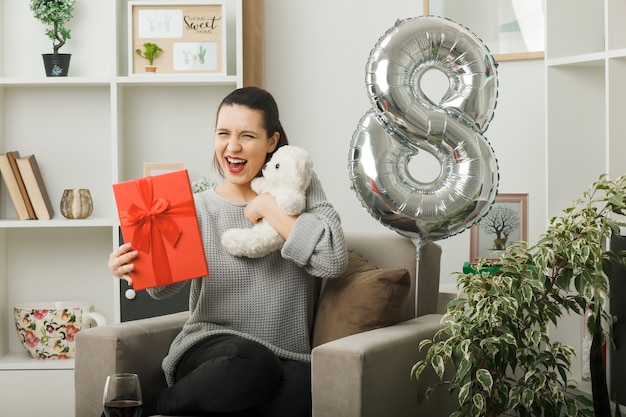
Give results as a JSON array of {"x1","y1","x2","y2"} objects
[{"x1": 312, "y1": 314, "x2": 457, "y2": 417}]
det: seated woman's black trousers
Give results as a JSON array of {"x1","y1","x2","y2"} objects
[{"x1": 157, "y1": 335, "x2": 311, "y2": 417}]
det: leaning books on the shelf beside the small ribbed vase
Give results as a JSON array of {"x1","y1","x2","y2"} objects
[{"x1": 0, "y1": 151, "x2": 54, "y2": 220}]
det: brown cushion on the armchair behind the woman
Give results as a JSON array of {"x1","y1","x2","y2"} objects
[{"x1": 313, "y1": 252, "x2": 411, "y2": 347}]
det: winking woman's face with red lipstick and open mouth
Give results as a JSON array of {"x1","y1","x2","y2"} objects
[{"x1": 215, "y1": 105, "x2": 279, "y2": 186}]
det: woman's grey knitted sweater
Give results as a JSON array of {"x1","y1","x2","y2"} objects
[{"x1": 147, "y1": 171, "x2": 348, "y2": 385}]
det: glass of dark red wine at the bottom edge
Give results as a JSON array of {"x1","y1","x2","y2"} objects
[{"x1": 103, "y1": 373, "x2": 142, "y2": 417}]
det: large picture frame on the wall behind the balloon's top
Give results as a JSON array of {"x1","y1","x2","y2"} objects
[{"x1": 423, "y1": 0, "x2": 545, "y2": 61}]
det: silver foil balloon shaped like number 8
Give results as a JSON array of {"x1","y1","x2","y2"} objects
[{"x1": 349, "y1": 16, "x2": 499, "y2": 240}]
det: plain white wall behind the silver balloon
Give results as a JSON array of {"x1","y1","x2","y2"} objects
[{"x1": 265, "y1": 0, "x2": 547, "y2": 290}]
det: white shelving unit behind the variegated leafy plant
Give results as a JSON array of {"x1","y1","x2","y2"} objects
[{"x1": 545, "y1": 0, "x2": 626, "y2": 404}]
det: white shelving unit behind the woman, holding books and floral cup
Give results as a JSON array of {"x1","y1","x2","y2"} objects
[{"x1": 0, "y1": 0, "x2": 243, "y2": 415}]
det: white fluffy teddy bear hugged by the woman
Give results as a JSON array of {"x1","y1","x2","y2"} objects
[{"x1": 222, "y1": 145, "x2": 313, "y2": 258}]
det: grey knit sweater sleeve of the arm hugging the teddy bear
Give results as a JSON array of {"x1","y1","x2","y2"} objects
[{"x1": 281, "y1": 174, "x2": 348, "y2": 278}]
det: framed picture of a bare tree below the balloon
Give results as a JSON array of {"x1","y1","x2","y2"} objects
[{"x1": 470, "y1": 194, "x2": 528, "y2": 263}]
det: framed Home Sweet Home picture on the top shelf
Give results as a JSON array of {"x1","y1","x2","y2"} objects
[{"x1": 128, "y1": 0, "x2": 227, "y2": 75}]
